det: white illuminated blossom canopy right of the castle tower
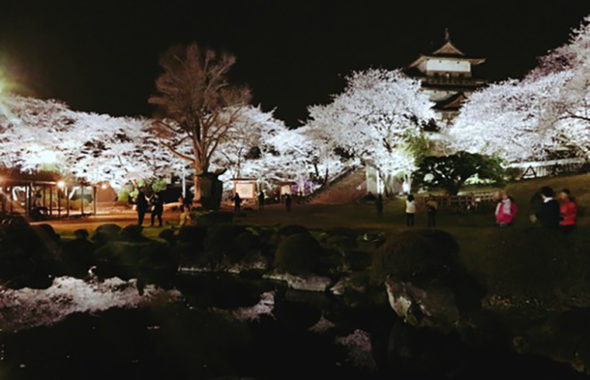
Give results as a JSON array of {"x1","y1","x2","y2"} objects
[{"x1": 449, "y1": 17, "x2": 590, "y2": 162}]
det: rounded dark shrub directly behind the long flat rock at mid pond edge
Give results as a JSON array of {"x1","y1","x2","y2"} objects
[{"x1": 274, "y1": 233, "x2": 323, "y2": 275}]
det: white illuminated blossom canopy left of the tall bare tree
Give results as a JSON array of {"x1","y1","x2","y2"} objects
[{"x1": 0, "y1": 95, "x2": 175, "y2": 187}]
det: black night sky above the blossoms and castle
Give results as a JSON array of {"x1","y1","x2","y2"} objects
[{"x1": 0, "y1": 0, "x2": 590, "y2": 126}]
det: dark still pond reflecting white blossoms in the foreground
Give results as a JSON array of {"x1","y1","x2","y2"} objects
[{"x1": 0, "y1": 275, "x2": 584, "y2": 380}]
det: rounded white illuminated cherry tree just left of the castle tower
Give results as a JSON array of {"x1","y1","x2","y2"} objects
[{"x1": 308, "y1": 69, "x2": 435, "y2": 191}]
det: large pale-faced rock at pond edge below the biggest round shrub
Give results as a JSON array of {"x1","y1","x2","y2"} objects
[{"x1": 385, "y1": 279, "x2": 461, "y2": 331}]
